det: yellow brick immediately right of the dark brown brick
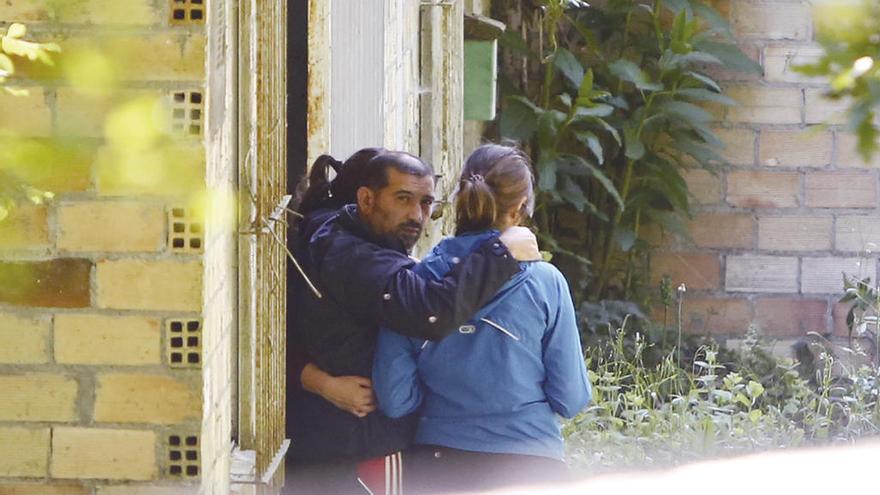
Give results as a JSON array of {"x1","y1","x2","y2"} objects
[{"x1": 97, "y1": 260, "x2": 202, "y2": 311}]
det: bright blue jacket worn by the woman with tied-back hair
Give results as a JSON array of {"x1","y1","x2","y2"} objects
[{"x1": 373, "y1": 231, "x2": 592, "y2": 459}]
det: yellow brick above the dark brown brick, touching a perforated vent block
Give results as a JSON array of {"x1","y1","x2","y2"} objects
[{"x1": 58, "y1": 201, "x2": 166, "y2": 251}]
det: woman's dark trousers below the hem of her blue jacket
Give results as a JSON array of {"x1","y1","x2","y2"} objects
[{"x1": 403, "y1": 445, "x2": 571, "y2": 495}]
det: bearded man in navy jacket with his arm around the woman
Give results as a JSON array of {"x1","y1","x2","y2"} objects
[{"x1": 288, "y1": 152, "x2": 539, "y2": 493}]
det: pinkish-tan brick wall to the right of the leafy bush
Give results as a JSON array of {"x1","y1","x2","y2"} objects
[{"x1": 652, "y1": 0, "x2": 880, "y2": 338}]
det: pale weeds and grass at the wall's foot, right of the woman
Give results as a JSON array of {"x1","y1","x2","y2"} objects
[{"x1": 565, "y1": 329, "x2": 880, "y2": 474}]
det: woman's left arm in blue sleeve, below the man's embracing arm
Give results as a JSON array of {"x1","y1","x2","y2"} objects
[{"x1": 373, "y1": 329, "x2": 422, "y2": 418}]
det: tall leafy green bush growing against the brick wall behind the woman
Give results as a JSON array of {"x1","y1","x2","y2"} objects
[{"x1": 497, "y1": 0, "x2": 760, "y2": 301}]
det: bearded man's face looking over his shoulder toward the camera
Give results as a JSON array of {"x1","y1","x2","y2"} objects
[{"x1": 358, "y1": 168, "x2": 434, "y2": 250}]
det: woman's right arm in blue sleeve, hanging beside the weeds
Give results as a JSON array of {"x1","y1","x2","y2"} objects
[{"x1": 542, "y1": 268, "x2": 593, "y2": 418}]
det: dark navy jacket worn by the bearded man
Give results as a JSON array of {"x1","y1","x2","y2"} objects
[{"x1": 288, "y1": 205, "x2": 520, "y2": 460}]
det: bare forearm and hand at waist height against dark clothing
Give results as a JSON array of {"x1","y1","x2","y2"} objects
[{"x1": 300, "y1": 363, "x2": 376, "y2": 418}]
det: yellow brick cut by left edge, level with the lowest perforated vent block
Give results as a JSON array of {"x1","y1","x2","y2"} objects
[{"x1": 0, "y1": 427, "x2": 49, "y2": 478}]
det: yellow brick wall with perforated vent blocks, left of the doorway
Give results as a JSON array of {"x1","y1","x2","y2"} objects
[{"x1": 0, "y1": 0, "x2": 206, "y2": 495}]
